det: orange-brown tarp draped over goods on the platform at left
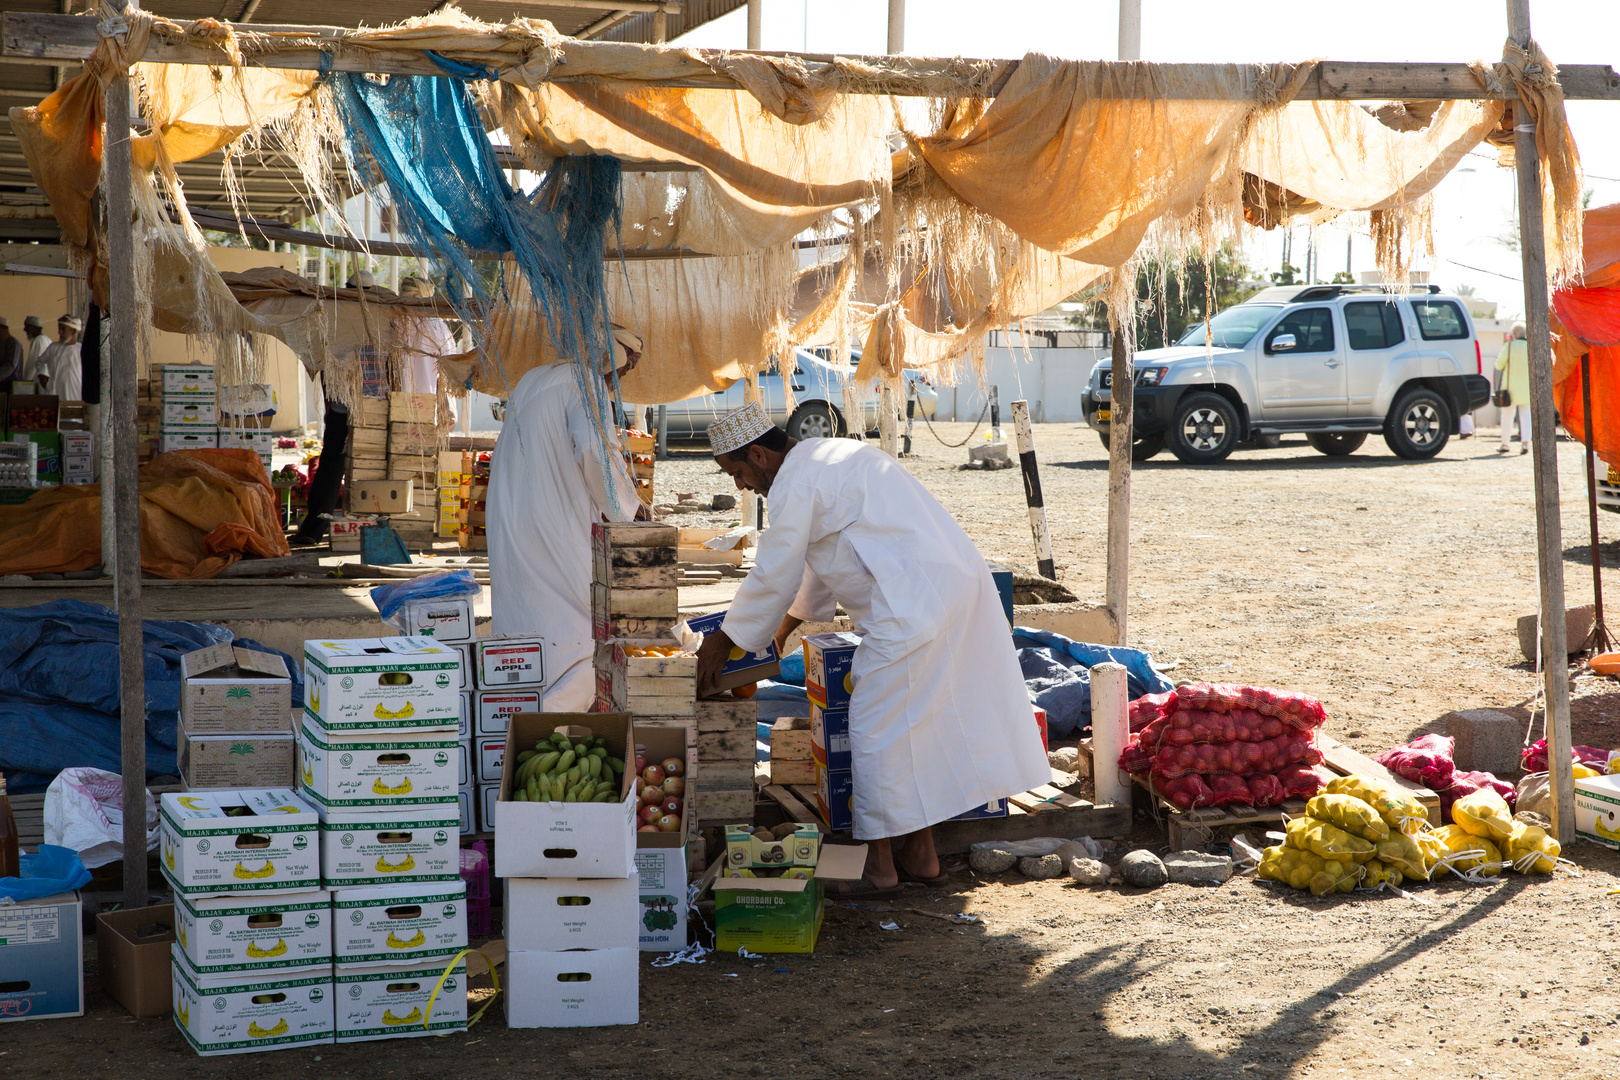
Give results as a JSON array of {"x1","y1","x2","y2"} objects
[{"x1": 0, "y1": 450, "x2": 292, "y2": 578}]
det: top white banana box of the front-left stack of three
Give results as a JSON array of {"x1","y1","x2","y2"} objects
[{"x1": 160, "y1": 789, "x2": 321, "y2": 897}]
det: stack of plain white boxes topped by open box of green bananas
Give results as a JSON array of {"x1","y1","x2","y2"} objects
[{"x1": 494, "y1": 712, "x2": 638, "y2": 1028}]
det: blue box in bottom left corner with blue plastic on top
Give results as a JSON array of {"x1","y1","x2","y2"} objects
[{"x1": 0, "y1": 892, "x2": 84, "y2": 1022}]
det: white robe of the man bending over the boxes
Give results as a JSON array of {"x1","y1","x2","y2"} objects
[{"x1": 724, "y1": 439, "x2": 1051, "y2": 840}]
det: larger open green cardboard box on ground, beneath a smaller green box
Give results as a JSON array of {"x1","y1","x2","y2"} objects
[{"x1": 713, "y1": 844, "x2": 867, "y2": 952}]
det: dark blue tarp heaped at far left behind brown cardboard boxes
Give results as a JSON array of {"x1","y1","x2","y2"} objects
[{"x1": 0, "y1": 601, "x2": 303, "y2": 792}]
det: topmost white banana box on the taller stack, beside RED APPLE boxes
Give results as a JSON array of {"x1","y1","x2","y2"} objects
[{"x1": 305, "y1": 638, "x2": 462, "y2": 732}]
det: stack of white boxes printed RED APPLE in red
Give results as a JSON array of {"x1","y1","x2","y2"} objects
[{"x1": 458, "y1": 638, "x2": 546, "y2": 832}]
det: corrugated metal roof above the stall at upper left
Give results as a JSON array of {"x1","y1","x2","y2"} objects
[{"x1": 0, "y1": 0, "x2": 745, "y2": 241}]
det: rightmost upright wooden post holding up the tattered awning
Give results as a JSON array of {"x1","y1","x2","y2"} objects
[{"x1": 1507, "y1": 0, "x2": 1575, "y2": 845}]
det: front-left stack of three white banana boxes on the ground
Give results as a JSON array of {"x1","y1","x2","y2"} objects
[{"x1": 160, "y1": 789, "x2": 335, "y2": 1056}]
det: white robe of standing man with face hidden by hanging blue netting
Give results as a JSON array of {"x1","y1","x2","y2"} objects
[{"x1": 484, "y1": 363, "x2": 642, "y2": 712}]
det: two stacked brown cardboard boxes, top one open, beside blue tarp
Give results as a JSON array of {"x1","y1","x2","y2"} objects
[{"x1": 177, "y1": 643, "x2": 296, "y2": 792}]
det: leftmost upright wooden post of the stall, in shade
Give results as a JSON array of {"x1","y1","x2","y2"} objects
[{"x1": 102, "y1": 2, "x2": 151, "y2": 908}]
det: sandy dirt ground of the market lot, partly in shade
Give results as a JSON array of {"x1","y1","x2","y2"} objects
[{"x1": 12, "y1": 424, "x2": 1620, "y2": 1080}]
